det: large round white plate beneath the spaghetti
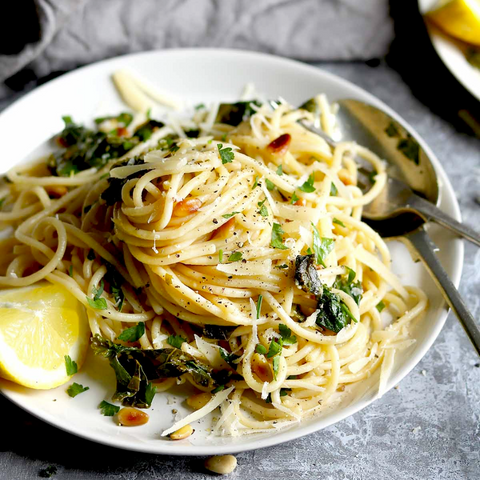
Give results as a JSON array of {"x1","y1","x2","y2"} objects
[{"x1": 0, "y1": 50, "x2": 463, "y2": 455}]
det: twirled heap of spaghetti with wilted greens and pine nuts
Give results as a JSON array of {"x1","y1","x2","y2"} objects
[{"x1": 0, "y1": 95, "x2": 427, "y2": 435}]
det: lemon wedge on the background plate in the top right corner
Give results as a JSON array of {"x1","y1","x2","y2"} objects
[{"x1": 426, "y1": 0, "x2": 480, "y2": 46}]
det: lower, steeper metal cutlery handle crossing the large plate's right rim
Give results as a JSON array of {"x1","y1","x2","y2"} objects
[{"x1": 403, "y1": 227, "x2": 480, "y2": 355}]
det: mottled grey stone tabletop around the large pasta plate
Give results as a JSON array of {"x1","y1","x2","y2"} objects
[{"x1": 0, "y1": 12, "x2": 480, "y2": 480}]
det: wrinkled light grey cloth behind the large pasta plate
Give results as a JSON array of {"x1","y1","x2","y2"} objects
[{"x1": 0, "y1": 0, "x2": 393, "y2": 81}]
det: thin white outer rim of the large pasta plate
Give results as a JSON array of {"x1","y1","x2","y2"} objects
[{"x1": 0, "y1": 48, "x2": 464, "y2": 456}]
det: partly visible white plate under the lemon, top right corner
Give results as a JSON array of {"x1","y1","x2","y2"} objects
[{"x1": 418, "y1": 0, "x2": 480, "y2": 100}]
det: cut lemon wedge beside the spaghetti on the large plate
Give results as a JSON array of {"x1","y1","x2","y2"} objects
[{"x1": 0, "y1": 283, "x2": 90, "y2": 389}]
